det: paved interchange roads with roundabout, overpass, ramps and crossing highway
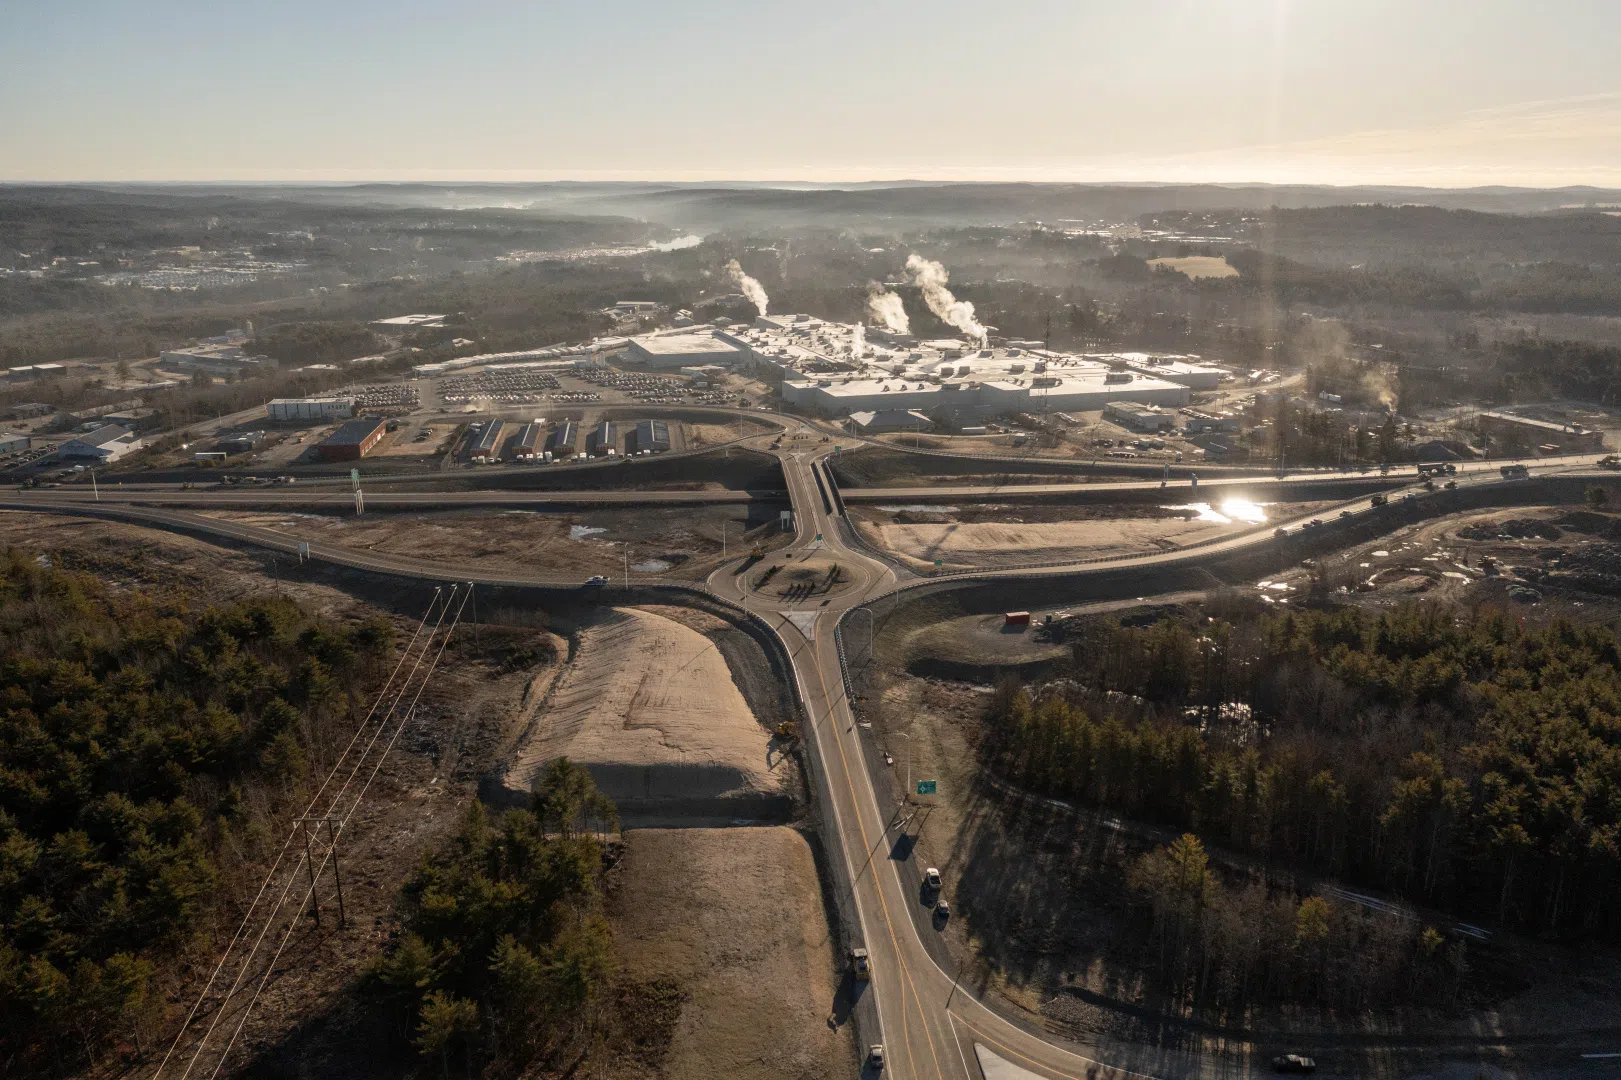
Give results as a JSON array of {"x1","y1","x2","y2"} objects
[{"x1": 0, "y1": 417, "x2": 1613, "y2": 1080}]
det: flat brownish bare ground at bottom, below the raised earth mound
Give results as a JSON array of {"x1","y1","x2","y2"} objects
[{"x1": 608, "y1": 827, "x2": 858, "y2": 1080}]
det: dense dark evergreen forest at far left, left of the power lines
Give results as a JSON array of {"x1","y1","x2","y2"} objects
[{"x1": 0, "y1": 551, "x2": 392, "y2": 1075}]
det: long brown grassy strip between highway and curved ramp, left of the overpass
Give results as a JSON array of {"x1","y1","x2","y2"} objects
[{"x1": 199, "y1": 505, "x2": 793, "y2": 581}]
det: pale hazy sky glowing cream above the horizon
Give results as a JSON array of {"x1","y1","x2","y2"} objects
[{"x1": 0, "y1": 0, "x2": 1621, "y2": 186}]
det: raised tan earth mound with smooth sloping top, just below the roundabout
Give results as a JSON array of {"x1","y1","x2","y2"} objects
[{"x1": 504, "y1": 608, "x2": 791, "y2": 822}]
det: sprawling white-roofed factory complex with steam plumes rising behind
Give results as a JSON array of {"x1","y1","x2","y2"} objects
[{"x1": 612, "y1": 315, "x2": 1230, "y2": 420}]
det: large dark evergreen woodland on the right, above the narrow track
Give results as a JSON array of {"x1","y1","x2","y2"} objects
[{"x1": 984, "y1": 603, "x2": 1621, "y2": 941}]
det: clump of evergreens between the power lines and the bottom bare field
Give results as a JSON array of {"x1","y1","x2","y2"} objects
[{"x1": 371, "y1": 759, "x2": 618, "y2": 1077}]
